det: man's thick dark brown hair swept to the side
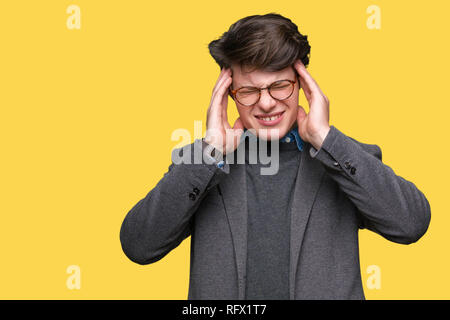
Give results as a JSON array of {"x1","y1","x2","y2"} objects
[{"x1": 208, "y1": 13, "x2": 311, "y2": 71}]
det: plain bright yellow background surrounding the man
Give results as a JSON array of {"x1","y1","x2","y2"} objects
[{"x1": 0, "y1": 0, "x2": 450, "y2": 299}]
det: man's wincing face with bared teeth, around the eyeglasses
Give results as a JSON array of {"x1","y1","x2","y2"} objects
[{"x1": 231, "y1": 64, "x2": 299, "y2": 140}]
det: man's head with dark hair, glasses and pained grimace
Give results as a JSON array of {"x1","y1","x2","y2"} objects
[{"x1": 209, "y1": 13, "x2": 311, "y2": 140}]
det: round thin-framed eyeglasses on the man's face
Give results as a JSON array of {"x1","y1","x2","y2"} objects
[{"x1": 229, "y1": 79, "x2": 296, "y2": 107}]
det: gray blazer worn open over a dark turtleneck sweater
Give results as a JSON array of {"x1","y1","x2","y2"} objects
[{"x1": 120, "y1": 126, "x2": 431, "y2": 300}]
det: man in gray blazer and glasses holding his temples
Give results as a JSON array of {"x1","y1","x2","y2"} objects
[{"x1": 120, "y1": 14, "x2": 431, "y2": 299}]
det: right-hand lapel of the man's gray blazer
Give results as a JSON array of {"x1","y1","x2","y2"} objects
[{"x1": 289, "y1": 143, "x2": 325, "y2": 300}]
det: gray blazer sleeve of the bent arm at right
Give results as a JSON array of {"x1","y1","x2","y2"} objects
[{"x1": 309, "y1": 126, "x2": 431, "y2": 244}]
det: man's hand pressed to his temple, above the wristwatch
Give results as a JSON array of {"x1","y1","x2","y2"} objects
[{"x1": 205, "y1": 68, "x2": 244, "y2": 155}]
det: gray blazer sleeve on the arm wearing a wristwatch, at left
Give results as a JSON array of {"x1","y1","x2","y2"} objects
[{"x1": 120, "y1": 139, "x2": 229, "y2": 265}]
